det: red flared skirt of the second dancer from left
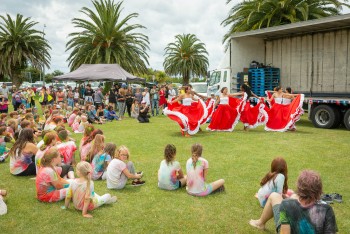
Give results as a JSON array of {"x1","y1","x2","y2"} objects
[{"x1": 207, "y1": 97, "x2": 243, "y2": 132}]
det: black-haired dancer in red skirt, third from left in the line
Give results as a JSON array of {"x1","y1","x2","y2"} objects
[{"x1": 240, "y1": 84, "x2": 268, "y2": 130}]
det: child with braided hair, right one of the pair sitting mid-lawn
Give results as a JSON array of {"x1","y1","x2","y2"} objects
[{"x1": 186, "y1": 143, "x2": 225, "y2": 196}]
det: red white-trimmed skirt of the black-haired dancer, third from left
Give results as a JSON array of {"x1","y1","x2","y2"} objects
[{"x1": 240, "y1": 101, "x2": 268, "y2": 128}]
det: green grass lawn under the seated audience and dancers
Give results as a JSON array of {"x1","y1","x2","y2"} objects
[{"x1": 0, "y1": 115, "x2": 350, "y2": 233}]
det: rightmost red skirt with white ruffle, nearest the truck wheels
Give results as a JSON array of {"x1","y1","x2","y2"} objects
[{"x1": 265, "y1": 94, "x2": 304, "y2": 132}]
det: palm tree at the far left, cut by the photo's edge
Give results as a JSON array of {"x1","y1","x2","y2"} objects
[{"x1": 0, "y1": 14, "x2": 51, "y2": 87}]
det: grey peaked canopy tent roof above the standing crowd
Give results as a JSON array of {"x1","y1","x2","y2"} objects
[{"x1": 53, "y1": 64, "x2": 146, "y2": 82}]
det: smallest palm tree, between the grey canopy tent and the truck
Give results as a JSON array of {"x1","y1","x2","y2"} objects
[{"x1": 163, "y1": 34, "x2": 209, "y2": 84}]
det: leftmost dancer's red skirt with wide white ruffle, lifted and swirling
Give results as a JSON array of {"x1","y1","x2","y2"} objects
[{"x1": 163, "y1": 99, "x2": 207, "y2": 135}]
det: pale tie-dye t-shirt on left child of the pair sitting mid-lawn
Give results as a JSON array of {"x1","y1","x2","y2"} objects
[{"x1": 158, "y1": 159, "x2": 181, "y2": 190}]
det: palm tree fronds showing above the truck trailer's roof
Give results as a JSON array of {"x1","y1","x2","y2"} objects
[{"x1": 221, "y1": 0, "x2": 349, "y2": 42}]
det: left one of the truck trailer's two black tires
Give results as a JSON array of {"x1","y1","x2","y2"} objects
[{"x1": 311, "y1": 105, "x2": 340, "y2": 129}]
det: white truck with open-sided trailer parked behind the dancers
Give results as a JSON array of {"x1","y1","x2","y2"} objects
[{"x1": 208, "y1": 14, "x2": 350, "y2": 130}]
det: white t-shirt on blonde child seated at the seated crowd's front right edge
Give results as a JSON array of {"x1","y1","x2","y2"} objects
[{"x1": 106, "y1": 158, "x2": 128, "y2": 189}]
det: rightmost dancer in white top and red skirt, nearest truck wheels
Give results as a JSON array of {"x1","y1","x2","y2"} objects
[{"x1": 265, "y1": 87, "x2": 304, "y2": 132}]
